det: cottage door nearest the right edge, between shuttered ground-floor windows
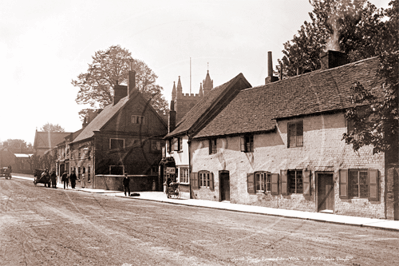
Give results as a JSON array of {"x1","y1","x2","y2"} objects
[{"x1": 317, "y1": 173, "x2": 334, "y2": 212}]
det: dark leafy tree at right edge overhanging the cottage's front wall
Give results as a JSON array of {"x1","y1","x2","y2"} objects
[{"x1": 343, "y1": 0, "x2": 399, "y2": 158}]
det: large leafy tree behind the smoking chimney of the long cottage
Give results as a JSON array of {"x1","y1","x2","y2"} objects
[{"x1": 277, "y1": 0, "x2": 384, "y2": 77}]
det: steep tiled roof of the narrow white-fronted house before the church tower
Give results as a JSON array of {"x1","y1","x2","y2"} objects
[{"x1": 166, "y1": 73, "x2": 251, "y2": 137}]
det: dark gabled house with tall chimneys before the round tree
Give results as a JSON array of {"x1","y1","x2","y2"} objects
[{"x1": 66, "y1": 71, "x2": 167, "y2": 191}]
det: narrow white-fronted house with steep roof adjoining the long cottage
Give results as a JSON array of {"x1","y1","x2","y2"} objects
[{"x1": 160, "y1": 74, "x2": 251, "y2": 198}]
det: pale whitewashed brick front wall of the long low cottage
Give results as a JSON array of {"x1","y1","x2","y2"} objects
[{"x1": 190, "y1": 113, "x2": 385, "y2": 218}]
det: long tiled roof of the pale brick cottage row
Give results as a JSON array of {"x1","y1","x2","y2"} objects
[{"x1": 194, "y1": 57, "x2": 380, "y2": 138}]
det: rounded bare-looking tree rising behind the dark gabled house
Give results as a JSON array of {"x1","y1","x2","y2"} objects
[{"x1": 72, "y1": 45, "x2": 167, "y2": 119}]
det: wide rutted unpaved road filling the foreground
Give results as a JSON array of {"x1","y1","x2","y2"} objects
[{"x1": 0, "y1": 175, "x2": 399, "y2": 266}]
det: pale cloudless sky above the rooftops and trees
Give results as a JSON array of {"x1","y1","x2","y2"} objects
[{"x1": 0, "y1": 0, "x2": 389, "y2": 144}]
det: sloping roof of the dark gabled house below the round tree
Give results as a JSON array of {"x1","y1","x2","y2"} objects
[{"x1": 73, "y1": 91, "x2": 166, "y2": 142}]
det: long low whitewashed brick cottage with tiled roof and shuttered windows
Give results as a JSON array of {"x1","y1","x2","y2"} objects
[{"x1": 190, "y1": 52, "x2": 396, "y2": 218}]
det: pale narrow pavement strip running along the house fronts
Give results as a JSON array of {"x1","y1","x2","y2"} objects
[{"x1": 12, "y1": 174, "x2": 399, "y2": 231}]
